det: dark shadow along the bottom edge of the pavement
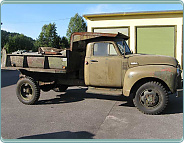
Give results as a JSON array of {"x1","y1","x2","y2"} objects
[{"x1": 18, "y1": 131, "x2": 94, "y2": 139}]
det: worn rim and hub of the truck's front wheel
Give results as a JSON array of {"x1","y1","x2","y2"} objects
[{"x1": 140, "y1": 89, "x2": 161, "y2": 109}]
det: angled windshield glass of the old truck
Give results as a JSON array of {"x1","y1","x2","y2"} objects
[{"x1": 117, "y1": 40, "x2": 131, "y2": 55}]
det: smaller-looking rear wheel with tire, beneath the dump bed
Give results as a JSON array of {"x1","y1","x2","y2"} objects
[{"x1": 16, "y1": 77, "x2": 40, "y2": 105}]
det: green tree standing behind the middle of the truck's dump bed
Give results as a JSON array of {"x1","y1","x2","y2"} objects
[{"x1": 35, "y1": 23, "x2": 61, "y2": 48}]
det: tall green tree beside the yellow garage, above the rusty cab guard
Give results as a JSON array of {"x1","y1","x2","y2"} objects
[{"x1": 66, "y1": 13, "x2": 87, "y2": 42}]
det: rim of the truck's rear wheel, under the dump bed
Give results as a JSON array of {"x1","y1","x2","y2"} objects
[{"x1": 20, "y1": 83, "x2": 33, "y2": 100}]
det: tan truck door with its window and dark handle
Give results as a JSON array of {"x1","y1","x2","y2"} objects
[{"x1": 85, "y1": 42, "x2": 122, "y2": 87}]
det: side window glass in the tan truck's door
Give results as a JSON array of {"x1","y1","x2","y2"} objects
[{"x1": 93, "y1": 42, "x2": 117, "y2": 56}]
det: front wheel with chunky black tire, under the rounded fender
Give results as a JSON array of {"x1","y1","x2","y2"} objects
[{"x1": 133, "y1": 81, "x2": 168, "y2": 115}]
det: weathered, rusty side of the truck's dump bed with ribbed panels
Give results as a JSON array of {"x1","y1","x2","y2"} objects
[{"x1": 1, "y1": 49, "x2": 67, "y2": 73}]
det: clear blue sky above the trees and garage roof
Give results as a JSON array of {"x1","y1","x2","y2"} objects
[{"x1": 1, "y1": 4, "x2": 183, "y2": 39}]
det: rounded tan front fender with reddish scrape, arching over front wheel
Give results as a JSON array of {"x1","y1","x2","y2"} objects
[{"x1": 123, "y1": 65, "x2": 177, "y2": 96}]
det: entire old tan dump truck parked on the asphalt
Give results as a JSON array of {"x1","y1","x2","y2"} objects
[{"x1": 1, "y1": 32, "x2": 181, "y2": 114}]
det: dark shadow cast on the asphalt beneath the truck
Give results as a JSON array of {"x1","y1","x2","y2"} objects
[{"x1": 37, "y1": 88, "x2": 183, "y2": 114}]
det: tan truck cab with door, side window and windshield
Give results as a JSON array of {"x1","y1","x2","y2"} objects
[{"x1": 84, "y1": 39, "x2": 131, "y2": 88}]
